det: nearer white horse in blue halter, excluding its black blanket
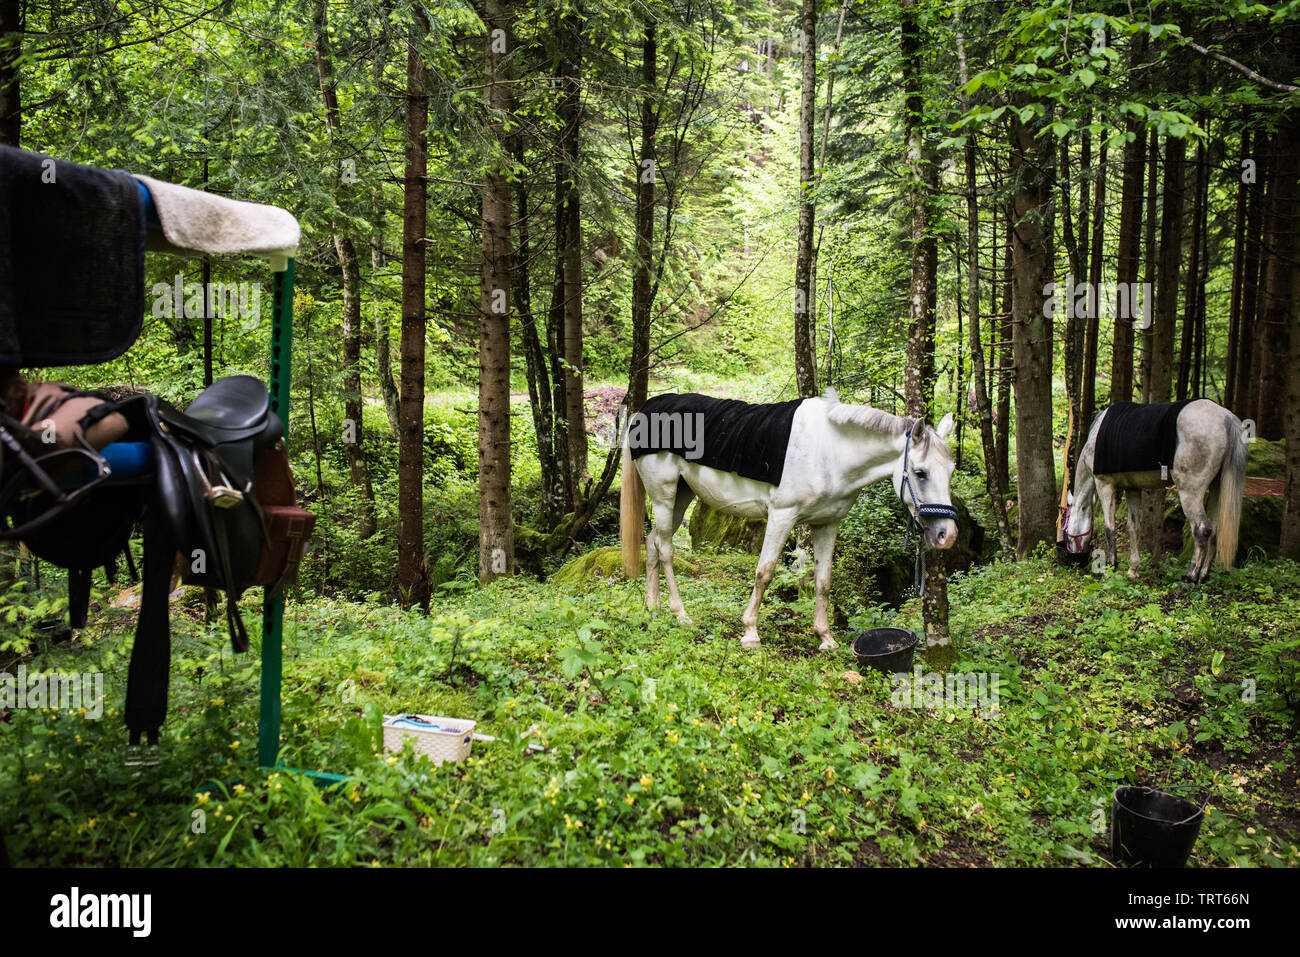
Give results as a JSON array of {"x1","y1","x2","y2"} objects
[{"x1": 619, "y1": 389, "x2": 957, "y2": 651}]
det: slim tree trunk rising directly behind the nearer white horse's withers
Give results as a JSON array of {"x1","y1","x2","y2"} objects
[{"x1": 794, "y1": 0, "x2": 816, "y2": 397}]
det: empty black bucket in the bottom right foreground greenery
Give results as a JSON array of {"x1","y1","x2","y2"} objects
[{"x1": 1110, "y1": 785, "x2": 1205, "y2": 867}]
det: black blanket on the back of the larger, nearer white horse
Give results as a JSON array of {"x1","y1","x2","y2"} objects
[{"x1": 628, "y1": 393, "x2": 803, "y2": 485}]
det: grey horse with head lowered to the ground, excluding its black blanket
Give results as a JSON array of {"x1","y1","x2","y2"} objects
[{"x1": 1065, "y1": 399, "x2": 1245, "y2": 583}]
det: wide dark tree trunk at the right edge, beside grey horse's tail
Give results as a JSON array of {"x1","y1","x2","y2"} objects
[{"x1": 1255, "y1": 112, "x2": 1300, "y2": 441}]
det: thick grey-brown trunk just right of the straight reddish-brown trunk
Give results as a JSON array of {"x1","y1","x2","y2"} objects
[{"x1": 478, "y1": 0, "x2": 515, "y2": 584}]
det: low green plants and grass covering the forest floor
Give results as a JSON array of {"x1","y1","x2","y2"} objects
[{"x1": 0, "y1": 553, "x2": 1300, "y2": 866}]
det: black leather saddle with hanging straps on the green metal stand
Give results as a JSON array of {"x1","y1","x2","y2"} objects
[{"x1": 0, "y1": 376, "x2": 285, "y2": 745}]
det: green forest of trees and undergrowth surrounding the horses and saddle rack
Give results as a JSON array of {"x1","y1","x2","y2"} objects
[{"x1": 0, "y1": 0, "x2": 1300, "y2": 866}]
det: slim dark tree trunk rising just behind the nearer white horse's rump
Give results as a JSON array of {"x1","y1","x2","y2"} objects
[{"x1": 627, "y1": 22, "x2": 659, "y2": 415}]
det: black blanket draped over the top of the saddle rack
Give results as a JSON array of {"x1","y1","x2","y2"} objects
[{"x1": 0, "y1": 146, "x2": 144, "y2": 367}]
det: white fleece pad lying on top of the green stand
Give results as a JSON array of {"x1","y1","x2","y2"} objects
[{"x1": 135, "y1": 176, "x2": 299, "y2": 256}]
